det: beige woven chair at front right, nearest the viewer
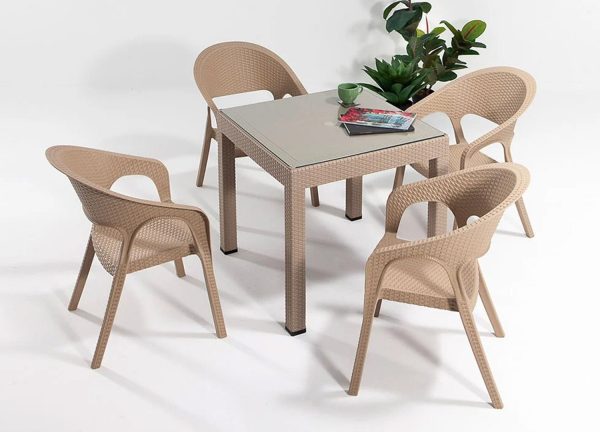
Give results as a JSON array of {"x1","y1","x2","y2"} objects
[{"x1": 348, "y1": 163, "x2": 529, "y2": 408}]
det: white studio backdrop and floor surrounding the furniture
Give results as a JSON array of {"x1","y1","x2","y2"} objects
[{"x1": 0, "y1": 0, "x2": 600, "y2": 431}]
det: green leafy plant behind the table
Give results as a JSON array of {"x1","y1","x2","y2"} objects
[{"x1": 361, "y1": 0, "x2": 486, "y2": 109}]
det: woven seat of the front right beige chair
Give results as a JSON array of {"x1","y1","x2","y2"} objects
[{"x1": 378, "y1": 233, "x2": 479, "y2": 311}]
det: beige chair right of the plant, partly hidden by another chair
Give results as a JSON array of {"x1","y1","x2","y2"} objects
[{"x1": 394, "y1": 67, "x2": 536, "y2": 237}]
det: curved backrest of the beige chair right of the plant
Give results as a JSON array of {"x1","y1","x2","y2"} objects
[{"x1": 409, "y1": 67, "x2": 536, "y2": 124}]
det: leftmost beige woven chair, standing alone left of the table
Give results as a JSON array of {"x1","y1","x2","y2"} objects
[{"x1": 46, "y1": 146, "x2": 227, "y2": 369}]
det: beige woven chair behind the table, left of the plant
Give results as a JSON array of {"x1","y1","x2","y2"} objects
[{"x1": 194, "y1": 42, "x2": 319, "y2": 207}]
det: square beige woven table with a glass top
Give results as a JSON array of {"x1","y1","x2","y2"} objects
[{"x1": 215, "y1": 89, "x2": 449, "y2": 336}]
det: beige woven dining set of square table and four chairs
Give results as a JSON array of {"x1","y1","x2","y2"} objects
[{"x1": 46, "y1": 42, "x2": 535, "y2": 408}]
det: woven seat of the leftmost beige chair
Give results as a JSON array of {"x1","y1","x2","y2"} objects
[{"x1": 92, "y1": 218, "x2": 195, "y2": 275}]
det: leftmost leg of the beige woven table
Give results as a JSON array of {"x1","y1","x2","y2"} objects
[{"x1": 219, "y1": 134, "x2": 237, "y2": 255}]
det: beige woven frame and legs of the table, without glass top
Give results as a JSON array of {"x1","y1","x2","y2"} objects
[{"x1": 215, "y1": 111, "x2": 449, "y2": 336}]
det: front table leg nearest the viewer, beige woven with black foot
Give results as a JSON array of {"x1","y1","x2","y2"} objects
[{"x1": 285, "y1": 185, "x2": 306, "y2": 336}]
